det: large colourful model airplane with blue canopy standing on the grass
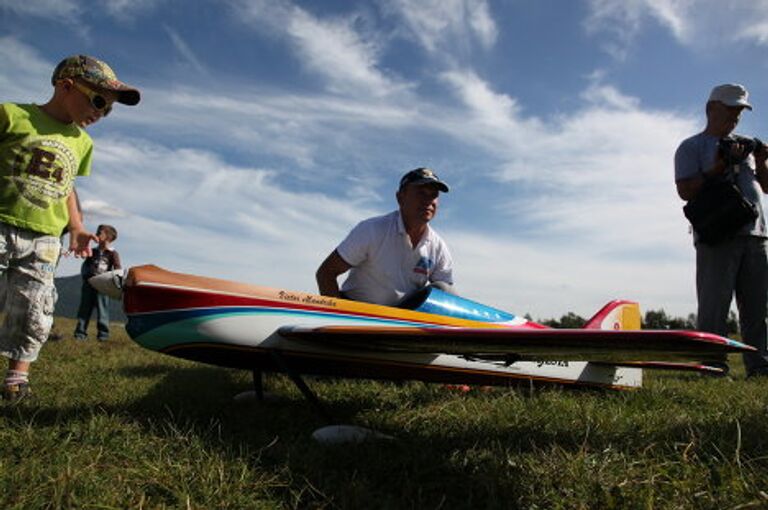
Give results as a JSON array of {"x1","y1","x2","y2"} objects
[{"x1": 91, "y1": 265, "x2": 753, "y2": 404}]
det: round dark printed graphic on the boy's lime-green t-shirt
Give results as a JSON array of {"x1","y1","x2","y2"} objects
[{"x1": 11, "y1": 137, "x2": 78, "y2": 209}]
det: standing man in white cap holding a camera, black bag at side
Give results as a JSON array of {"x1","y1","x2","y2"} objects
[{"x1": 675, "y1": 84, "x2": 768, "y2": 377}]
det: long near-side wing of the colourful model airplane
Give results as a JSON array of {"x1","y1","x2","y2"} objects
[{"x1": 278, "y1": 326, "x2": 755, "y2": 362}]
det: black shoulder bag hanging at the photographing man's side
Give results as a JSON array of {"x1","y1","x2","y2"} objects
[{"x1": 683, "y1": 175, "x2": 758, "y2": 244}]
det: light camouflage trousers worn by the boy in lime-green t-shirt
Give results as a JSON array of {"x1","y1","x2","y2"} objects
[{"x1": 0, "y1": 223, "x2": 61, "y2": 361}]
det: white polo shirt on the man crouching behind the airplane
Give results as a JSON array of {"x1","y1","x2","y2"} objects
[{"x1": 336, "y1": 210, "x2": 453, "y2": 306}]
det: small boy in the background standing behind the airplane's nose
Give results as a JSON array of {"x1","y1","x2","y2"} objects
[{"x1": 75, "y1": 225, "x2": 122, "y2": 342}]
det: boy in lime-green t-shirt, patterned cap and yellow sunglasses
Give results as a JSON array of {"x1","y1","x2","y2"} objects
[{"x1": 0, "y1": 55, "x2": 140, "y2": 401}]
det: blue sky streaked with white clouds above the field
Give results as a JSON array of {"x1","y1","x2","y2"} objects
[{"x1": 0, "y1": 0, "x2": 768, "y2": 319}]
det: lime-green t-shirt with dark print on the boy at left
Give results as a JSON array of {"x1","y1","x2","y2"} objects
[{"x1": 0, "y1": 103, "x2": 93, "y2": 236}]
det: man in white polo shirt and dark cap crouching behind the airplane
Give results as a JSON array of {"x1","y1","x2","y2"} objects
[{"x1": 316, "y1": 168, "x2": 453, "y2": 306}]
